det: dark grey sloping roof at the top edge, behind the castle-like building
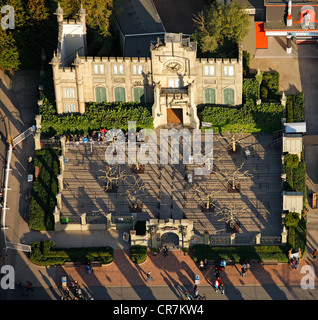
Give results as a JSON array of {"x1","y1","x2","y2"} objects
[{"x1": 116, "y1": 0, "x2": 165, "y2": 35}]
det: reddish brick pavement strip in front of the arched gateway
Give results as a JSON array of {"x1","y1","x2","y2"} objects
[{"x1": 56, "y1": 250, "x2": 318, "y2": 287}]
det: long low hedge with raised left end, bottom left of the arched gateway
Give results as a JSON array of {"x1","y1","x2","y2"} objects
[{"x1": 30, "y1": 240, "x2": 114, "y2": 266}]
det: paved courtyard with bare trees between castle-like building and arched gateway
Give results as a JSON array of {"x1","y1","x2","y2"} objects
[{"x1": 61, "y1": 133, "x2": 282, "y2": 240}]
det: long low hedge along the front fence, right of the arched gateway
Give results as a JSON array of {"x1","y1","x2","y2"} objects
[{"x1": 192, "y1": 245, "x2": 288, "y2": 263}]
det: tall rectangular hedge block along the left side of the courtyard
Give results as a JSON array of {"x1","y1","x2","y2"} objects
[{"x1": 29, "y1": 148, "x2": 60, "y2": 231}]
